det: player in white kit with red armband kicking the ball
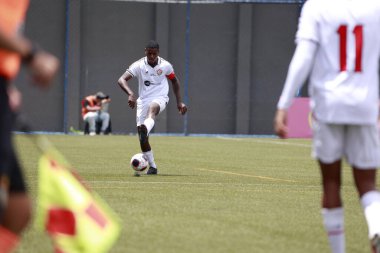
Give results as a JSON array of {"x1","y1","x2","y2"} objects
[{"x1": 118, "y1": 40, "x2": 187, "y2": 175}]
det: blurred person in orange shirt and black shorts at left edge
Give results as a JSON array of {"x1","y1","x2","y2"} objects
[{"x1": 0, "y1": 0, "x2": 59, "y2": 253}]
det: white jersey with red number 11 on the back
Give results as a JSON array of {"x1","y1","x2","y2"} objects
[{"x1": 296, "y1": 0, "x2": 380, "y2": 124}]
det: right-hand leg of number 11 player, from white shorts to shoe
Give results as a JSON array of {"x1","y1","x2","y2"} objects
[{"x1": 347, "y1": 126, "x2": 380, "y2": 253}]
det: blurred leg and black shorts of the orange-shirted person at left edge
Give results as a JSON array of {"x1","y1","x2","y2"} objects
[{"x1": 0, "y1": 85, "x2": 31, "y2": 253}]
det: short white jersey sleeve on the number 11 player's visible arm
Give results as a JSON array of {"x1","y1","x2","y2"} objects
[{"x1": 296, "y1": 0, "x2": 319, "y2": 43}]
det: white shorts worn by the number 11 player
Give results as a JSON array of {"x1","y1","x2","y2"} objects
[{"x1": 312, "y1": 121, "x2": 380, "y2": 169}]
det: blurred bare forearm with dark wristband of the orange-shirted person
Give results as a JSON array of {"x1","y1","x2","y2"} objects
[{"x1": 0, "y1": 30, "x2": 59, "y2": 87}]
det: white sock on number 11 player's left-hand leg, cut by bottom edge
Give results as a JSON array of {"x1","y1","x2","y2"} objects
[{"x1": 322, "y1": 207, "x2": 346, "y2": 253}]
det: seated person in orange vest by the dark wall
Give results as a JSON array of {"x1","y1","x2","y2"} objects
[{"x1": 82, "y1": 91, "x2": 111, "y2": 136}]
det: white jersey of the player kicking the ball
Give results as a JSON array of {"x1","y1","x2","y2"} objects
[{"x1": 127, "y1": 57, "x2": 174, "y2": 99}]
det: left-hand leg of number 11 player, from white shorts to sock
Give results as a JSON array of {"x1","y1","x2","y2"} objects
[{"x1": 313, "y1": 122, "x2": 345, "y2": 253}]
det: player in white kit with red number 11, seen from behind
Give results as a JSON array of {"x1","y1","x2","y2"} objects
[{"x1": 274, "y1": 0, "x2": 380, "y2": 253}]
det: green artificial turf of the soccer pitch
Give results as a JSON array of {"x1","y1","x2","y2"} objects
[{"x1": 15, "y1": 135, "x2": 369, "y2": 253}]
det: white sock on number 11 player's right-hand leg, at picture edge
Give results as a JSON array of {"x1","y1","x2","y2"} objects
[{"x1": 360, "y1": 191, "x2": 380, "y2": 239}]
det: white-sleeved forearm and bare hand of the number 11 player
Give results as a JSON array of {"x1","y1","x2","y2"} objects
[{"x1": 274, "y1": 40, "x2": 318, "y2": 138}]
